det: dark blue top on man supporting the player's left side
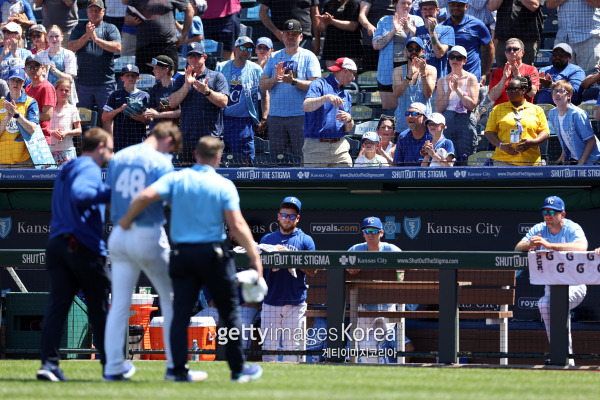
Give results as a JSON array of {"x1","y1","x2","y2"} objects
[{"x1": 50, "y1": 156, "x2": 110, "y2": 256}]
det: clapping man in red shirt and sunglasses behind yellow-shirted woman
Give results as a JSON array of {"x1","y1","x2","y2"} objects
[{"x1": 489, "y1": 38, "x2": 540, "y2": 106}]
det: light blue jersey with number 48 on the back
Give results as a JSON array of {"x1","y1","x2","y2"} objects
[{"x1": 106, "y1": 143, "x2": 173, "y2": 226}]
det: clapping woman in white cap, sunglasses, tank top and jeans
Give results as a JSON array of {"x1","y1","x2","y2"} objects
[{"x1": 435, "y1": 46, "x2": 479, "y2": 165}]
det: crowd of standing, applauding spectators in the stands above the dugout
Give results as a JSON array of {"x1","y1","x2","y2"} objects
[{"x1": 0, "y1": 0, "x2": 600, "y2": 167}]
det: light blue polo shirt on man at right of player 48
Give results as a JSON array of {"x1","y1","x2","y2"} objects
[{"x1": 152, "y1": 164, "x2": 240, "y2": 243}]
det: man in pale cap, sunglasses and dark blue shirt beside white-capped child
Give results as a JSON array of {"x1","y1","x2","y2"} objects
[{"x1": 394, "y1": 103, "x2": 433, "y2": 167}]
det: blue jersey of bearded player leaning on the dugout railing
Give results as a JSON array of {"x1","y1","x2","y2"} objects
[{"x1": 260, "y1": 229, "x2": 315, "y2": 306}]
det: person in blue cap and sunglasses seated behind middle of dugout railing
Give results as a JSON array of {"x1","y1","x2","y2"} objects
[{"x1": 347, "y1": 217, "x2": 415, "y2": 363}]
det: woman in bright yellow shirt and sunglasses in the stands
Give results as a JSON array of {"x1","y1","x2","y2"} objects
[{"x1": 485, "y1": 76, "x2": 550, "y2": 166}]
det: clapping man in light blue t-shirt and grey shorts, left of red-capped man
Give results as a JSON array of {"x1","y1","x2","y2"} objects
[{"x1": 260, "y1": 19, "x2": 321, "y2": 156}]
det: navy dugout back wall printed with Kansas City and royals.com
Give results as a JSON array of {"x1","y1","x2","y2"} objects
[{"x1": 0, "y1": 210, "x2": 600, "y2": 320}]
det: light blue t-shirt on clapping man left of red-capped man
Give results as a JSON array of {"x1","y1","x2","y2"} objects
[{"x1": 263, "y1": 48, "x2": 321, "y2": 117}]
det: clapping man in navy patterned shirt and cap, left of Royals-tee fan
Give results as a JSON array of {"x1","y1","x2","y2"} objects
[{"x1": 169, "y1": 42, "x2": 229, "y2": 165}]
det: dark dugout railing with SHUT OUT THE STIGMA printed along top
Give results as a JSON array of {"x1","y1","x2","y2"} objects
[{"x1": 0, "y1": 250, "x2": 584, "y2": 365}]
